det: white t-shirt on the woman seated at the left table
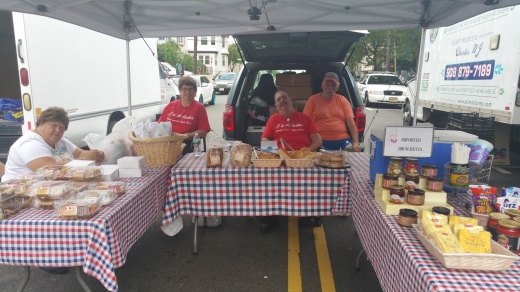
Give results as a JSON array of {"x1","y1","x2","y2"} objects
[{"x1": 2, "y1": 131, "x2": 76, "y2": 182}]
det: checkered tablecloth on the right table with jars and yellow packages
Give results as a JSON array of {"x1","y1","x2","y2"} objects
[{"x1": 351, "y1": 154, "x2": 520, "y2": 292}]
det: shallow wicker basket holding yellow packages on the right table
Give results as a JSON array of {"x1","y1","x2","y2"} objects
[{"x1": 413, "y1": 224, "x2": 520, "y2": 271}]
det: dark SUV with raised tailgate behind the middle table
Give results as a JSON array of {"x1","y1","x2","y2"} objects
[{"x1": 223, "y1": 31, "x2": 366, "y2": 146}]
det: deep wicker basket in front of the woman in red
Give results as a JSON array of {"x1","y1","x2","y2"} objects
[{"x1": 128, "y1": 132, "x2": 187, "y2": 167}]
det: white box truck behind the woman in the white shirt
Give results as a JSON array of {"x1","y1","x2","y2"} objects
[{"x1": 0, "y1": 11, "x2": 173, "y2": 159}]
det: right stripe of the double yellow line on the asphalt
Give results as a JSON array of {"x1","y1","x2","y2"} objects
[{"x1": 313, "y1": 224, "x2": 336, "y2": 292}]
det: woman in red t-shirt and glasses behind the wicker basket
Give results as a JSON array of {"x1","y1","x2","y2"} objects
[{"x1": 158, "y1": 76, "x2": 211, "y2": 154}]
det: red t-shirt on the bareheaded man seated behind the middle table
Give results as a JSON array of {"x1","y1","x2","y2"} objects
[{"x1": 262, "y1": 111, "x2": 319, "y2": 150}]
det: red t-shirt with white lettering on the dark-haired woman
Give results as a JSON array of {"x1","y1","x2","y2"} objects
[{"x1": 157, "y1": 99, "x2": 211, "y2": 134}]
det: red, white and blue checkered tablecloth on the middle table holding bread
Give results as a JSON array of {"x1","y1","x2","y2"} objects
[{"x1": 162, "y1": 154, "x2": 351, "y2": 225}]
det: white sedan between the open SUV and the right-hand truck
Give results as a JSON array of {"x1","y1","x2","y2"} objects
[{"x1": 357, "y1": 73, "x2": 410, "y2": 106}]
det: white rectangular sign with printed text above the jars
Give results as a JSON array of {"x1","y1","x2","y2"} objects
[{"x1": 383, "y1": 127, "x2": 433, "y2": 157}]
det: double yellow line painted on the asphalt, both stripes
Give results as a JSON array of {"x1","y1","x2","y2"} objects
[{"x1": 287, "y1": 217, "x2": 336, "y2": 292}]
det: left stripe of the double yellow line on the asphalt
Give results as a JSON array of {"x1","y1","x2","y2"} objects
[{"x1": 287, "y1": 217, "x2": 302, "y2": 292}]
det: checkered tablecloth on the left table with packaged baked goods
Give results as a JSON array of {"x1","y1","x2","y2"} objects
[{"x1": 0, "y1": 167, "x2": 170, "y2": 291}]
